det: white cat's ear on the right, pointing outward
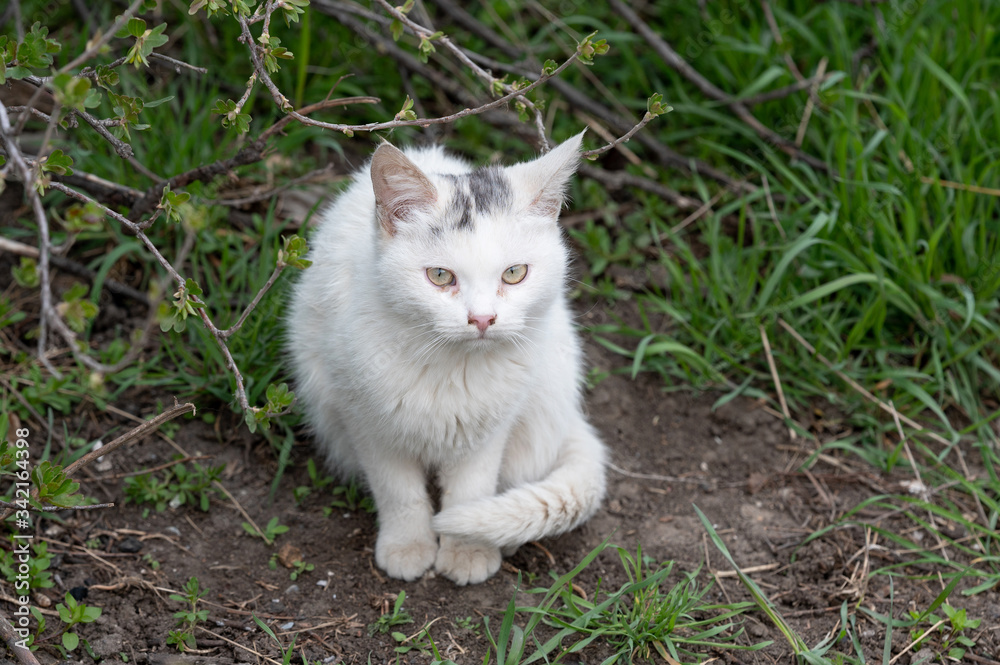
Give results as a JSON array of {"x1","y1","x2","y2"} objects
[{"x1": 507, "y1": 130, "x2": 586, "y2": 218}]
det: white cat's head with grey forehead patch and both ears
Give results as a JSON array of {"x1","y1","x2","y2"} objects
[{"x1": 371, "y1": 134, "x2": 583, "y2": 345}]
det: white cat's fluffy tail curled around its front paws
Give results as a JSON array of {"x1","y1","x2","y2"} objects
[{"x1": 433, "y1": 423, "x2": 606, "y2": 549}]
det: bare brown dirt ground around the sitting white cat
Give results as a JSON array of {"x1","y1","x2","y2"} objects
[{"x1": 7, "y1": 292, "x2": 1000, "y2": 665}]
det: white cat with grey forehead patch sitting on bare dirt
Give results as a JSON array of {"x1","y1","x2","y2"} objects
[{"x1": 288, "y1": 134, "x2": 605, "y2": 584}]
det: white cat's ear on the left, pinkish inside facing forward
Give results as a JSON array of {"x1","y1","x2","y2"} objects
[{"x1": 371, "y1": 142, "x2": 437, "y2": 236}]
